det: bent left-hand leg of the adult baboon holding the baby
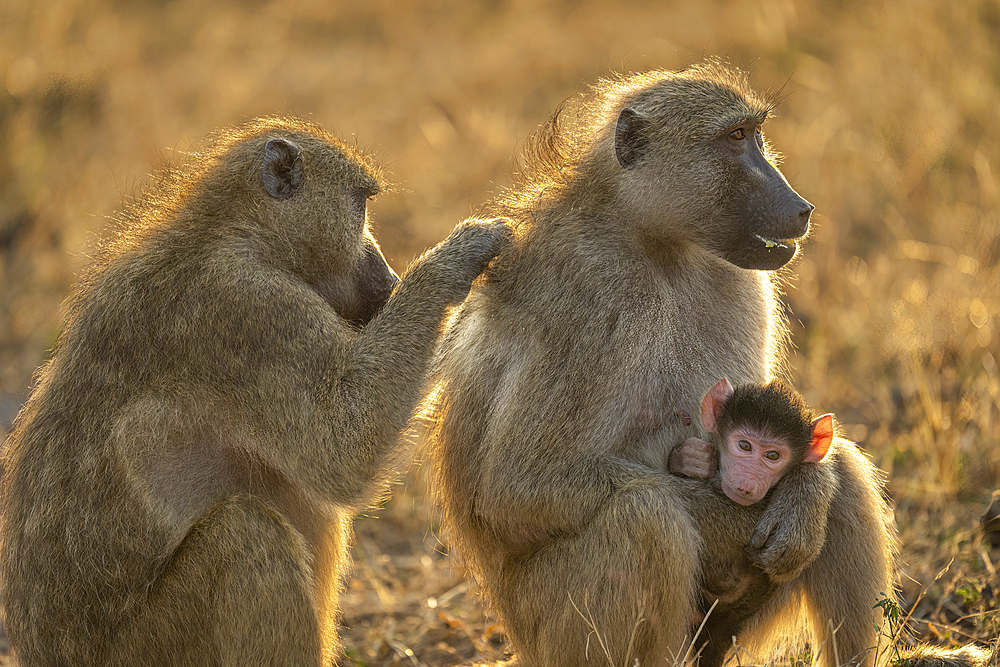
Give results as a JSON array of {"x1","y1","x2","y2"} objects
[{"x1": 491, "y1": 487, "x2": 700, "y2": 667}]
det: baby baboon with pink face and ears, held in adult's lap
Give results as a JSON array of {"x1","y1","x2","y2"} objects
[{"x1": 670, "y1": 378, "x2": 833, "y2": 667}]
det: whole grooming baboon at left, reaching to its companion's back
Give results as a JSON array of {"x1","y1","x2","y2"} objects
[{"x1": 0, "y1": 118, "x2": 508, "y2": 667}]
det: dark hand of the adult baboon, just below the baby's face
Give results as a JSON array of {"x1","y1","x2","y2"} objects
[{"x1": 746, "y1": 498, "x2": 826, "y2": 582}]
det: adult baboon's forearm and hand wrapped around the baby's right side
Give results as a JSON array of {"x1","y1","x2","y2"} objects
[{"x1": 747, "y1": 444, "x2": 837, "y2": 582}]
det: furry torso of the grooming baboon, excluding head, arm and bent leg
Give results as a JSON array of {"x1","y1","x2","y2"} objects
[{"x1": 5, "y1": 194, "x2": 353, "y2": 656}]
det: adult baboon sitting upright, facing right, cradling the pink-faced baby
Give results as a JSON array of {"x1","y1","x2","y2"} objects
[{"x1": 426, "y1": 62, "x2": 984, "y2": 667}]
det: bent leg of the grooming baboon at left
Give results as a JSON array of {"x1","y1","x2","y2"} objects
[{"x1": 110, "y1": 495, "x2": 332, "y2": 667}]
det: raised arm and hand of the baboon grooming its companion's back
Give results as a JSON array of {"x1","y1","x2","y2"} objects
[{"x1": 214, "y1": 219, "x2": 507, "y2": 508}]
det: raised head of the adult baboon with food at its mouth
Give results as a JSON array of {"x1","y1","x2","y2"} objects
[{"x1": 611, "y1": 63, "x2": 813, "y2": 270}]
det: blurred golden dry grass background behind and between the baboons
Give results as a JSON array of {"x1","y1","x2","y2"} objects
[{"x1": 0, "y1": 0, "x2": 1000, "y2": 665}]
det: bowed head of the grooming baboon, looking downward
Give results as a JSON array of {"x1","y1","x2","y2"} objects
[{"x1": 229, "y1": 121, "x2": 399, "y2": 325}]
